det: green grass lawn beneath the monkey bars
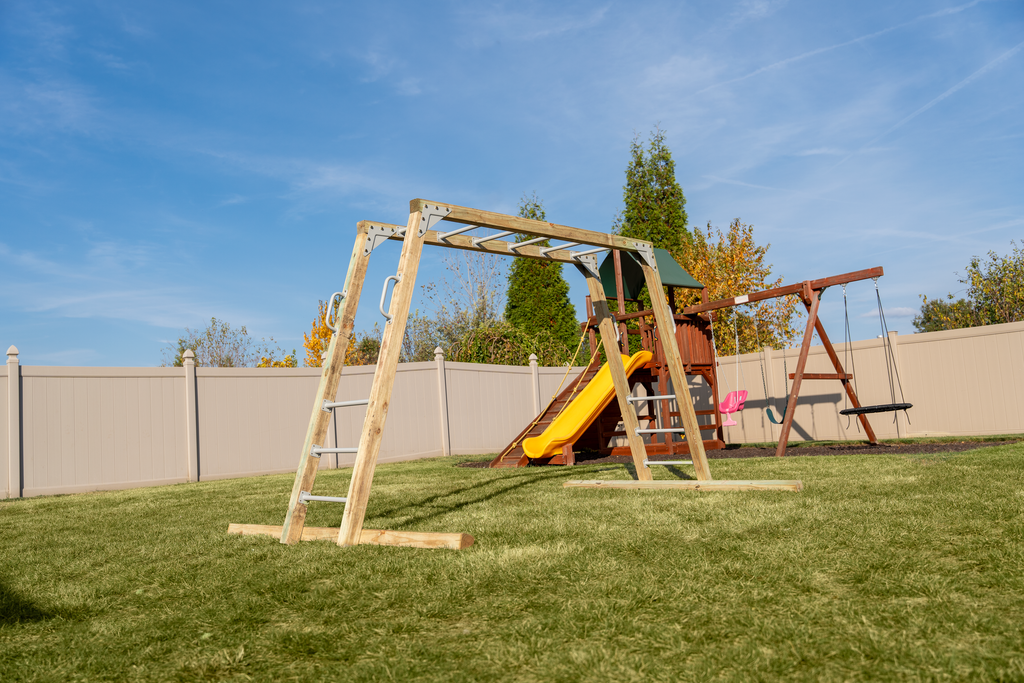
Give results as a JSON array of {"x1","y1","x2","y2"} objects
[{"x1": 0, "y1": 444, "x2": 1024, "y2": 682}]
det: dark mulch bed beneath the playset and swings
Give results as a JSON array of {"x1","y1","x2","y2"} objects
[{"x1": 458, "y1": 441, "x2": 1017, "y2": 467}]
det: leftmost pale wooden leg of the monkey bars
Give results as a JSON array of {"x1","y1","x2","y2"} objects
[{"x1": 281, "y1": 226, "x2": 370, "y2": 545}]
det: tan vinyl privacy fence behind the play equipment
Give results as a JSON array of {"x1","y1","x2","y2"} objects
[{"x1": 0, "y1": 323, "x2": 1024, "y2": 497}]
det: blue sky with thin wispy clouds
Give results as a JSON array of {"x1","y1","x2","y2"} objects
[{"x1": 0, "y1": 0, "x2": 1024, "y2": 366}]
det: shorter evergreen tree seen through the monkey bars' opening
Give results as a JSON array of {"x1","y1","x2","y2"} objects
[{"x1": 505, "y1": 193, "x2": 580, "y2": 360}]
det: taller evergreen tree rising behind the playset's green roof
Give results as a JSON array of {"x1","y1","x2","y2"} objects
[{"x1": 612, "y1": 128, "x2": 690, "y2": 261}]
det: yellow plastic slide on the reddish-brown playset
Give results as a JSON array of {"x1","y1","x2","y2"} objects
[{"x1": 522, "y1": 351, "x2": 652, "y2": 458}]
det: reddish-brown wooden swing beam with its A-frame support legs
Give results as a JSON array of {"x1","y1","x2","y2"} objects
[{"x1": 683, "y1": 266, "x2": 885, "y2": 458}]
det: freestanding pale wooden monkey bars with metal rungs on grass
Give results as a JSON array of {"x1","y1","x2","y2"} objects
[{"x1": 228, "y1": 199, "x2": 802, "y2": 549}]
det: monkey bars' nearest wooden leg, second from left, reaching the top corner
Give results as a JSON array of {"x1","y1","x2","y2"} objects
[{"x1": 338, "y1": 211, "x2": 425, "y2": 546}]
